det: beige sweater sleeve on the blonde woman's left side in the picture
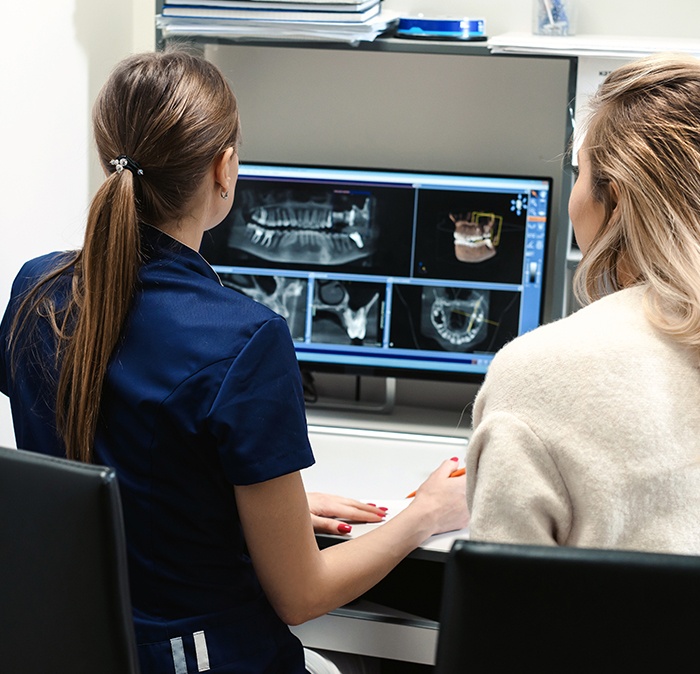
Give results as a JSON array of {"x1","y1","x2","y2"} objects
[{"x1": 466, "y1": 411, "x2": 571, "y2": 545}]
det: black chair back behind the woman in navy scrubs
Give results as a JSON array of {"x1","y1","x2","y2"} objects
[{"x1": 0, "y1": 448, "x2": 138, "y2": 674}]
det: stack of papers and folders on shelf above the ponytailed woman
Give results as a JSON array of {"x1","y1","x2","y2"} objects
[{"x1": 157, "y1": 0, "x2": 398, "y2": 43}]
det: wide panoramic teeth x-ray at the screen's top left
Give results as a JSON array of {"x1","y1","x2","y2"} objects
[{"x1": 230, "y1": 190, "x2": 374, "y2": 265}]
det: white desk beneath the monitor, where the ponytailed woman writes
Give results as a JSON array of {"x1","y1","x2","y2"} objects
[{"x1": 293, "y1": 425, "x2": 468, "y2": 665}]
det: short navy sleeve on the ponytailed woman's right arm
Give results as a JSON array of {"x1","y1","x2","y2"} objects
[{"x1": 207, "y1": 318, "x2": 314, "y2": 485}]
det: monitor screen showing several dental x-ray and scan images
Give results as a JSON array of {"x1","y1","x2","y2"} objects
[{"x1": 202, "y1": 164, "x2": 552, "y2": 380}]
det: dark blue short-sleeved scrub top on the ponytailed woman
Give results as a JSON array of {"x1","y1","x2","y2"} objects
[{"x1": 0, "y1": 226, "x2": 313, "y2": 674}]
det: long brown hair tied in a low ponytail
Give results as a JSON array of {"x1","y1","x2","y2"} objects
[{"x1": 11, "y1": 50, "x2": 239, "y2": 462}]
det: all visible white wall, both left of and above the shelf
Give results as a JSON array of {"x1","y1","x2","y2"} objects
[{"x1": 0, "y1": 0, "x2": 700, "y2": 445}]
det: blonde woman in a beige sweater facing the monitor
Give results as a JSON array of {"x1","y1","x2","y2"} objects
[{"x1": 467, "y1": 55, "x2": 700, "y2": 554}]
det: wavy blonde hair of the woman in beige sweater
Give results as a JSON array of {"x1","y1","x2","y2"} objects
[{"x1": 574, "y1": 54, "x2": 700, "y2": 356}]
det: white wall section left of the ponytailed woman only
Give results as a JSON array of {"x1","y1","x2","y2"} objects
[{"x1": 0, "y1": 0, "x2": 155, "y2": 445}]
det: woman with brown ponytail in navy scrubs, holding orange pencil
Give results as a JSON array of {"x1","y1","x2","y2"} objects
[{"x1": 0, "y1": 51, "x2": 468, "y2": 674}]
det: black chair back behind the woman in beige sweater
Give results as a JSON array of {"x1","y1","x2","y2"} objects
[{"x1": 435, "y1": 541, "x2": 700, "y2": 674}]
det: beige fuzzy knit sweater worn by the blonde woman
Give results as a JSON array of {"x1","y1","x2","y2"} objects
[{"x1": 467, "y1": 288, "x2": 700, "y2": 554}]
